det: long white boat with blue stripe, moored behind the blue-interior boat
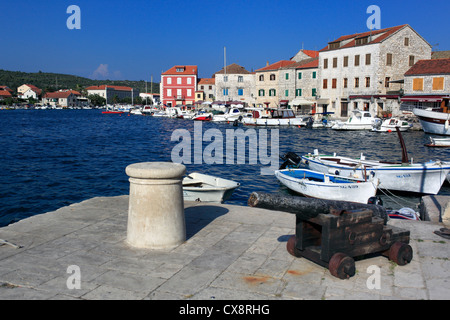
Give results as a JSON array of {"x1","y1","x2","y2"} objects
[{"x1": 302, "y1": 154, "x2": 450, "y2": 194}]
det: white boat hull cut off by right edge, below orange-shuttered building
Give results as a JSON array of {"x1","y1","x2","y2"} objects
[{"x1": 413, "y1": 108, "x2": 450, "y2": 136}]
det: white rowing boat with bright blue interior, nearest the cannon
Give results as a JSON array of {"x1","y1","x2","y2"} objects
[{"x1": 275, "y1": 169, "x2": 378, "y2": 203}]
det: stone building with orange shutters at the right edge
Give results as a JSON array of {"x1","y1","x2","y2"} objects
[{"x1": 401, "y1": 58, "x2": 450, "y2": 111}]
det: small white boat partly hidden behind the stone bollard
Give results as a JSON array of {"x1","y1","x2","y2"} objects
[{"x1": 183, "y1": 172, "x2": 240, "y2": 203}]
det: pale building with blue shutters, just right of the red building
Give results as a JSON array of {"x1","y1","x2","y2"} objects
[{"x1": 213, "y1": 63, "x2": 256, "y2": 105}]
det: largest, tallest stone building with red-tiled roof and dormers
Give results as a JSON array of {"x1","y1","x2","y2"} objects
[{"x1": 317, "y1": 25, "x2": 431, "y2": 117}]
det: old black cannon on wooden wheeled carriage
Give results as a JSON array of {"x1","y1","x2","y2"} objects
[{"x1": 248, "y1": 193, "x2": 413, "y2": 279}]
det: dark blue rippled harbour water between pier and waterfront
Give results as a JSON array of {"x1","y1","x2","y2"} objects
[{"x1": 0, "y1": 110, "x2": 450, "y2": 227}]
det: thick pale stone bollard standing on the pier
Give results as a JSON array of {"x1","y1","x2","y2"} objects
[{"x1": 125, "y1": 162, "x2": 186, "y2": 249}]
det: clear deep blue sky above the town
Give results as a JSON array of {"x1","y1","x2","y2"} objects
[{"x1": 0, "y1": 0, "x2": 450, "y2": 81}]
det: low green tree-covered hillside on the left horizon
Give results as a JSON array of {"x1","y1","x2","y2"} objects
[{"x1": 0, "y1": 69, "x2": 159, "y2": 93}]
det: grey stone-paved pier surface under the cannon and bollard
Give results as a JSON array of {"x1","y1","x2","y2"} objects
[{"x1": 0, "y1": 195, "x2": 450, "y2": 300}]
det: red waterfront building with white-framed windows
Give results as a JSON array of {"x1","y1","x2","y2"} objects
[{"x1": 159, "y1": 65, "x2": 198, "y2": 106}]
